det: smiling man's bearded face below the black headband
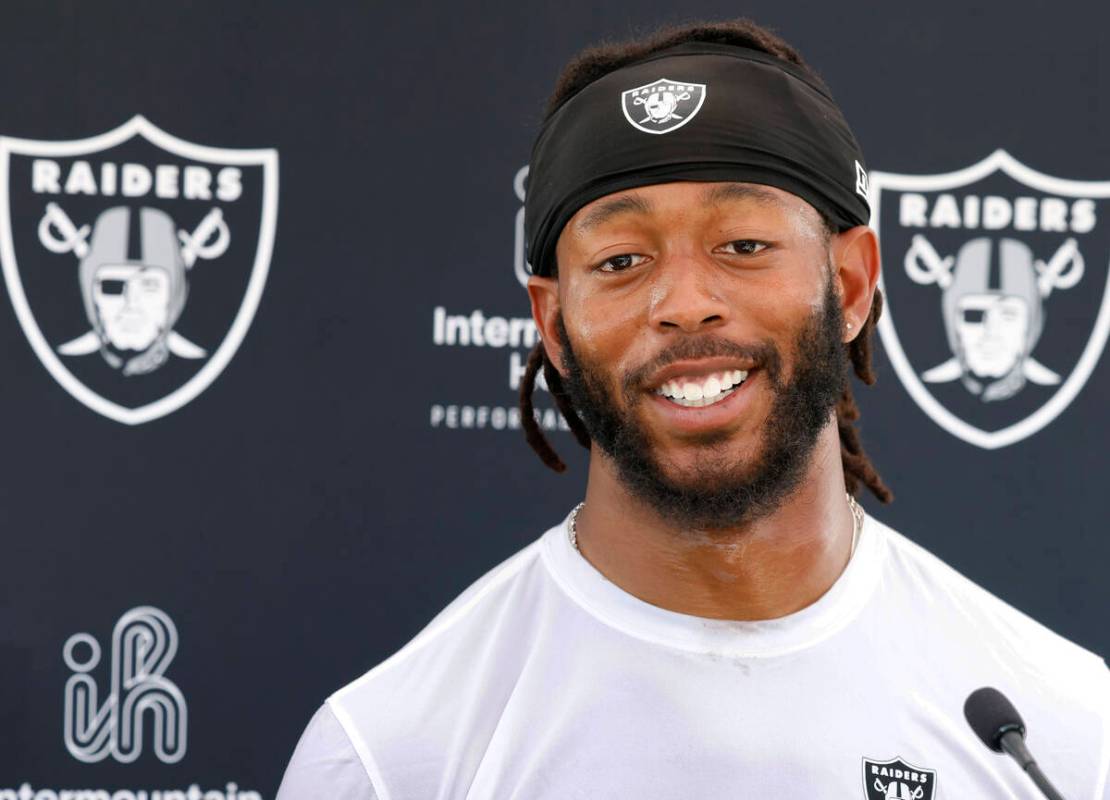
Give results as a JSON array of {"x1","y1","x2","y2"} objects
[{"x1": 548, "y1": 183, "x2": 846, "y2": 528}]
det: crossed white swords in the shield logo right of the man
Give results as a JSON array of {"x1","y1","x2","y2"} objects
[{"x1": 904, "y1": 234, "x2": 1086, "y2": 386}]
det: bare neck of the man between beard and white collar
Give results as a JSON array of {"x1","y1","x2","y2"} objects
[{"x1": 576, "y1": 426, "x2": 855, "y2": 620}]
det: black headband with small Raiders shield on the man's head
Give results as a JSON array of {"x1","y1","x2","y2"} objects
[{"x1": 524, "y1": 42, "x2": 870, "y2": 275}]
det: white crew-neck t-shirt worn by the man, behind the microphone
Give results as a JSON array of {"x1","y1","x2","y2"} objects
[{"x1": 278, "y1": 518, "x2": 1110, "y2": 800}]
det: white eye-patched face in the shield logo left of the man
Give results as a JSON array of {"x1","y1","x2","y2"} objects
[{"x1": 92, "y1": 264, "x2": 170, "y2": 351}]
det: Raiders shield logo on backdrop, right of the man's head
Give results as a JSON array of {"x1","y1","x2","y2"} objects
[{"x1": 869, "y1": 150, "x2": 1110, "y2": 449}]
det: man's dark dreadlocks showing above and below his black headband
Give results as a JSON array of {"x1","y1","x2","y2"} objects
[{"x1": 521, "y1": 19, "x2": 894, "y2": 503}]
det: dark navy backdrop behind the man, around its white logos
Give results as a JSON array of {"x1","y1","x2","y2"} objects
[{"x1": 0, "y1": 0, "x2": 1110, "y2": 800}]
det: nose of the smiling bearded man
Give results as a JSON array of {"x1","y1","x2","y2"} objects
[{"x1": 649, "y1": 257, "x2": 728, "y2": 333}]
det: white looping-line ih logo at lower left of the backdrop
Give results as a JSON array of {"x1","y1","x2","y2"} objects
[{"x1": 62, "y1": 606, "x2": 188, "y2": 763}]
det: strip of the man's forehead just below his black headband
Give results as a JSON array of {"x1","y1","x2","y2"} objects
[{"x1": 563, "y1": 181, "x2": 821, "y2": 235}]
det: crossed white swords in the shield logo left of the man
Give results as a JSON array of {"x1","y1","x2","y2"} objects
[{"x1": 39, "y1": 203, "x2": 231, "y2": 358}]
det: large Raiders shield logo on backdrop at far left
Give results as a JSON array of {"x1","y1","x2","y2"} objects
[{"x1": 0, "y1": 117, "x2": 278, "y2": 425}]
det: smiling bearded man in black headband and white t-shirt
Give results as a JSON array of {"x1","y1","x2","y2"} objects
[{"x1": 279, "y1": 22, "x2": 1110, "y2": 800}]
